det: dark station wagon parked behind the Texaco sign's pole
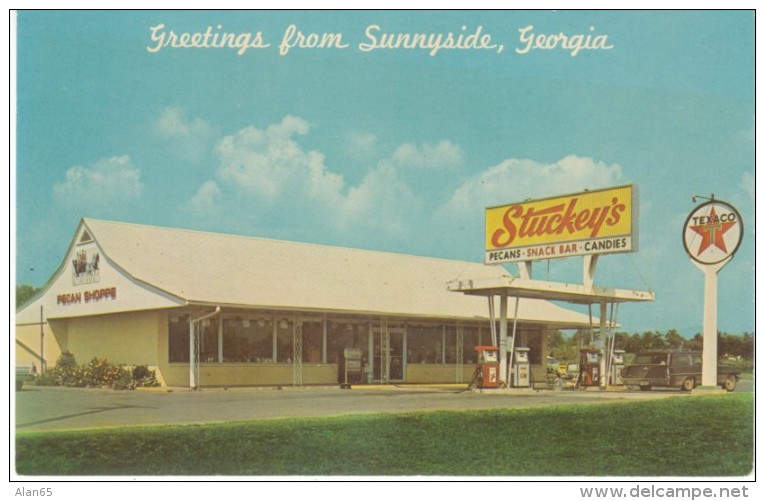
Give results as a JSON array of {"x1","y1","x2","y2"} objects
[{"x1": 622, "y1": 350, "x2": 741, "y2": 391}]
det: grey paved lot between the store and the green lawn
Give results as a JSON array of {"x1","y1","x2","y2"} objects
[{"x1": 15, "y1": 385, "x2": 739, "y2": 432}]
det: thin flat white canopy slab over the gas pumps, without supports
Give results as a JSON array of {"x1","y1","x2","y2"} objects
[{"x1": 446, "y1": 275, "x2": 656, "y2": 304}]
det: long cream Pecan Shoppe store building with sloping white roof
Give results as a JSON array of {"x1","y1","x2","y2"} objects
[{"x1": 16, "y1": 219, "x2": 604, "y2": 387}]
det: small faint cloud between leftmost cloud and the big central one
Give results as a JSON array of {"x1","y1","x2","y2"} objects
[{"x1": 154, "y1": 106, "x2": 213, "y2": 160}]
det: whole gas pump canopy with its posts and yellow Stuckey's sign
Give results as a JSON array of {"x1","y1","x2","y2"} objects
[{"x1": 454, "y1": 185, "x2": 656, "y2": 386}]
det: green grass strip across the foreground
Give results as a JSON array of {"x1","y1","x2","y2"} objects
[{"x1": 16, "y1": 393, "x2": 754, "y2": 476}]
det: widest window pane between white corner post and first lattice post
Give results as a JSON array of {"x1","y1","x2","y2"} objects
[{"x1": 223, "y1": 317, "x2": 274, "y2": 363}]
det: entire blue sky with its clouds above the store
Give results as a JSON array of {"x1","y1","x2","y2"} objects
[{"x1": 15, "y1": 11, "x2": 755, "y2": 336}]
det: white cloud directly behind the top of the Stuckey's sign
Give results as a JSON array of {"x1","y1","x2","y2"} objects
[{"x1": 445, "y1": 155, "x2": 622, "y2": 214}]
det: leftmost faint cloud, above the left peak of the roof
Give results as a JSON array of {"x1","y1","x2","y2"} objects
[{"x1": 53, "y1": 155, "x2": 143, "y2": 209}]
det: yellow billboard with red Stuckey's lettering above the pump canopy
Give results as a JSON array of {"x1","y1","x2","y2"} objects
[{"x1": 485, "y1": 185, "x2": 637, "y2": 264}]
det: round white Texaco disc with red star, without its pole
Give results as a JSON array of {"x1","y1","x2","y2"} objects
[{"x1": 683, "y1": 200, "x2": 744, "y2": 264}]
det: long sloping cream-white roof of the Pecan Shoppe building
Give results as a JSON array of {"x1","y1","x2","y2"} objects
[{"x1": 83, "y1": 219, "x2": 589, "y2": 327}]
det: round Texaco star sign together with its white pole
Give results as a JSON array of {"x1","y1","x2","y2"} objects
[{"x1": 683, "y1": 195, "x2": 744, "y2": 388}]
